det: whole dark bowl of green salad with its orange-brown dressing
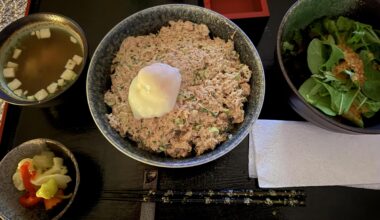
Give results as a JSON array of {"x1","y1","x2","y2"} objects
[{"x1": 277, "y1": 0, "x2": 380, "y2": 134}]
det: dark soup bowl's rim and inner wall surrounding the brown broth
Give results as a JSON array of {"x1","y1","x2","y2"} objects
[{"x1": 0, "y1": 13, "x2": 88, "y2": 106}]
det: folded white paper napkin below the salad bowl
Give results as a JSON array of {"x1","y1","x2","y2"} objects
[{"x1": 249, "y1": 120, "x2": 380, "y2": 189}]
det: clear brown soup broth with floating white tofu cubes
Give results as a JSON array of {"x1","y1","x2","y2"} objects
[{"x1": 2, "y1": 23, "x2": 83, "y2": 101}]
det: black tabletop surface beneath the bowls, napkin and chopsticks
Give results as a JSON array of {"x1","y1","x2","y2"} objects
[{"x1": 0, "y1": 0, "x2": 380, "y2": 219}]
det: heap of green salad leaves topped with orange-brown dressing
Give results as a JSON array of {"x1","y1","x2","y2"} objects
[{"x1": 294, "y1": 16, "x2": 380, "y2": 127}]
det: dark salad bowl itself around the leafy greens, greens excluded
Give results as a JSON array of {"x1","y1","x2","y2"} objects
[{"x1": 277, "y1": 0, "x2": 380, "y2": 134}]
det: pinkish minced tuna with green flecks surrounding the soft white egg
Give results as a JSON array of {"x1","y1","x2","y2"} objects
[{"x1": 104, "y1": 21, "x2": 252, "y2": 158}]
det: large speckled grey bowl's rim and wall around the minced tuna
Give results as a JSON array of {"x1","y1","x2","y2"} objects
[{"x1": 87, "y1": 4, "x2": 265, "y2": 167}]
